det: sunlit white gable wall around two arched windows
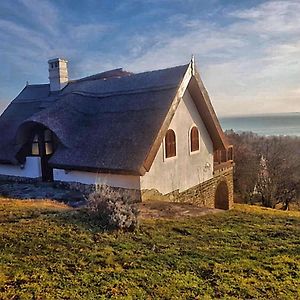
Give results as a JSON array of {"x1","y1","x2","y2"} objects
[{"x1": 141, "y1": 90, "x2": 213, "y2": 194}]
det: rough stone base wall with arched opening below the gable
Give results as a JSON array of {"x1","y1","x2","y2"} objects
[{"x1": 142, "y1": 167, "x2": 233, "y2": 209}]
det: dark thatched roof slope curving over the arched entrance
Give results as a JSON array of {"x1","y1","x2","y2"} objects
[{"x1": 0, "y1": 64, "x2": 227, "y2": 174}]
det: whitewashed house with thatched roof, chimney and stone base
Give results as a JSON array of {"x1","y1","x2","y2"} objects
[{"x1": 0, "y1": 58, "x2": 233, "y2": 209}]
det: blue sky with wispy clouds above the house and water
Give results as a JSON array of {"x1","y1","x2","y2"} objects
[{"x1": 0, "y1": 0, "x2": 300, "y2": 116}]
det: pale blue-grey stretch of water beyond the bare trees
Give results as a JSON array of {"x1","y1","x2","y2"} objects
[{"x1": 220, "y1": 112, "x2": 300, "y2": 136}]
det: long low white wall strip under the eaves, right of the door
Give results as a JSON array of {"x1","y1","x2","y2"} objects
[{"x1": 53, "y1": 169, "x2": 140, "y2": 189}]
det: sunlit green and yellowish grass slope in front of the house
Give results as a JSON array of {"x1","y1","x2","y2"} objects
[{"x1": 0, "y1": 200, "x2": 300, "y2": 299}]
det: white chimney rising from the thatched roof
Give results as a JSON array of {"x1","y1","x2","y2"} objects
[{"x1": 48, "y1": 58, "x2": 69, "y2": 92}]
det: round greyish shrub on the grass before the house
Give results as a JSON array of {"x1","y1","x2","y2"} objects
[{"x1": 88, "y1": 185, "x2": 139, "y2": 231}]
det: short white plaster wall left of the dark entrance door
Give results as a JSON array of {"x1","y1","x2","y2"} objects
[{"x1": 0, "y1": 157, "x2": 42, "y2": 178}]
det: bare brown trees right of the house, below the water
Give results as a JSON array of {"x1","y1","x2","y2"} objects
[{"x1": 226, "y1": 130, "x2": 300, "y2": 209}]
